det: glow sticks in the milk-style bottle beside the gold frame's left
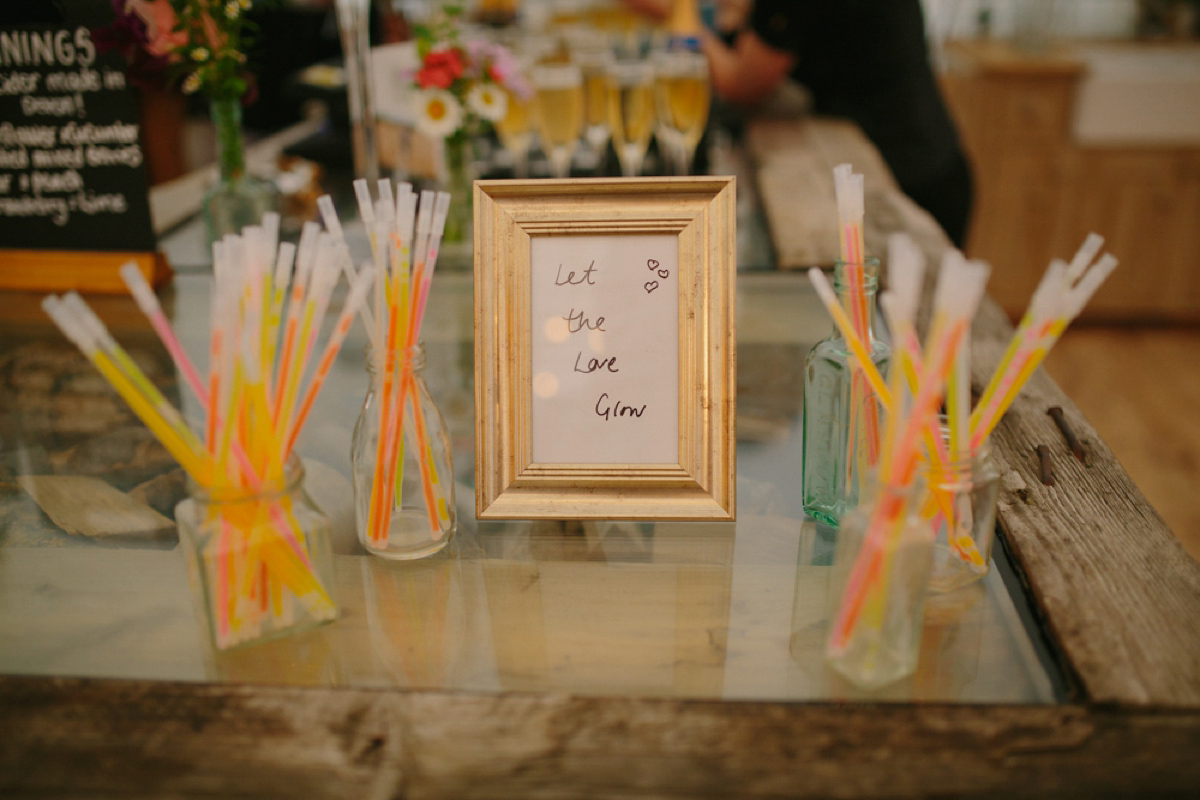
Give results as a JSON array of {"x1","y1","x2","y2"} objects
[{"x1": 319, "y1": 180, "x2": 451, "y2": 551}]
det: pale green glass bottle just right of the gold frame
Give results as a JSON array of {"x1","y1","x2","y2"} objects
[{"x1": 800, "y1": 258, "x2": 892, "y2": 527}]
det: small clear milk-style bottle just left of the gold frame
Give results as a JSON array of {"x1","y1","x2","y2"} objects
[{"x1": 350, "y1": 344, "x2": 457, "y2": 559}]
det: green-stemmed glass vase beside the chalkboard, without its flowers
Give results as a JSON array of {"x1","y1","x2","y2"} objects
[{"x1": 203, "y1": 97, "x2": 278, "y2": 242}]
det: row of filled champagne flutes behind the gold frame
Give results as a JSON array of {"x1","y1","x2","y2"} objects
[{"x1": 496, "y1": 52, "x2": 709, "y2": 178}]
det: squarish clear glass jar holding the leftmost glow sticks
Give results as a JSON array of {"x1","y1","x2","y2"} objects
[{"x1": 175, "y1": 456, "x2": 337, "y2": 650}]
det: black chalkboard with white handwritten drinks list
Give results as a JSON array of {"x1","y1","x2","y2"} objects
[{"x1": 0, "y1": 0, "x2": 162, "y2": 291}]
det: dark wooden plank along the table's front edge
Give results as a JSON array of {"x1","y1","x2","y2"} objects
[{"x1": 0, "y1": 678, "x2": 1200, "y2": 800}]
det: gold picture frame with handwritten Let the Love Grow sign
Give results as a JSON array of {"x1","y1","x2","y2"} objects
[{"x1": 474, "y1": 178, "x2": 736, "y2": 519}]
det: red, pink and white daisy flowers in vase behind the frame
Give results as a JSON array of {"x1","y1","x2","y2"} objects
[{"x1": 410, "y1": 5, "x2": 532, "y2": 243}]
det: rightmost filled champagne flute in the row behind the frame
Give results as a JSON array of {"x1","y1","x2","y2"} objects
[{"x1": 654, "y1": 50, "x2": 710, "y2": 175}]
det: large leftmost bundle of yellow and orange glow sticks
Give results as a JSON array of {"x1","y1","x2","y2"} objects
[{"x1": 43, "y1": 213, "x2": 374, "y2": 649}]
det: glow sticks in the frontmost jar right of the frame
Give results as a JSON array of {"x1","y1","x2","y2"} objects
[{"x1": 810, "y1": 251, "x2": 988, "y2": 656}]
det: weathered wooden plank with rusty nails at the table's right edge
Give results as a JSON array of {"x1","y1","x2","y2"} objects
[{"x1": 973, "y1": 298, "x2": 1200, "y2": 708}]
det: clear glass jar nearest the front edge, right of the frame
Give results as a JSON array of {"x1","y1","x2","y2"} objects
[{"x1": 826, "y1": 486, "x2": 934, "y2": 691}]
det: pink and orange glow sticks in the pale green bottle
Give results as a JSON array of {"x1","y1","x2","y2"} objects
[{"x1": 833, "y1": 164, "x2": 880, "y2": 474}]
